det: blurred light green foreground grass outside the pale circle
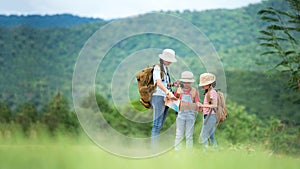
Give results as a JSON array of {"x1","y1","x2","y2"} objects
[{"x1": 0, "y1": 133, "x2": 300, "y2": 169}]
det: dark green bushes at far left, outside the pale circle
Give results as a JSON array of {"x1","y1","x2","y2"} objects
[{"x1": 0, "y1": 92, "x2": 80, "y2": 137}]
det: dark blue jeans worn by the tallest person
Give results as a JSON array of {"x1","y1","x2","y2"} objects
[{"x1": 151, "y1": 95, "x2": 168, "y2": 148}]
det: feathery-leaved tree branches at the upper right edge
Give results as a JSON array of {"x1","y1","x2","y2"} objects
[{"x1": 258, "y1": 0, "x2": 300, "y2": 91}]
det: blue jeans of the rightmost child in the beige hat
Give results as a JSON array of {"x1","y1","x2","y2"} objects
[{"x1": 199, "y1": 114, "x2": 217, "y2": 148}]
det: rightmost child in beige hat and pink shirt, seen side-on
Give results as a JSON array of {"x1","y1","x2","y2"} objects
[{"x1": 198, "y1": 73, "x2": 218, "y2": 151}]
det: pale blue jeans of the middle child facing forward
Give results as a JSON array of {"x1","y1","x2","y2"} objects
[{"x1": 175, "y1": 110, "x2": 195, "y2": 150}]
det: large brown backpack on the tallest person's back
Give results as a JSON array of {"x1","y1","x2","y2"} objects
[{"x1": 136, "y1": 65, "x2": 164, "y2": 109}]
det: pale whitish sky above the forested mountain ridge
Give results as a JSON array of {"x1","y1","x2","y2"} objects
[{"x1": 0, "y1": 0, "x2": 262, "y2": 19}]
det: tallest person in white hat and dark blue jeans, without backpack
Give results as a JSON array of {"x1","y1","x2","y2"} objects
[{"x1": 151, "y1": 49, "x2": 177, "y2": 147}]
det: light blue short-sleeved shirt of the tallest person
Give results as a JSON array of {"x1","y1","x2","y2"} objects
[{"x1": 153, "y1": 65, "x2": 169, "y2": 96}]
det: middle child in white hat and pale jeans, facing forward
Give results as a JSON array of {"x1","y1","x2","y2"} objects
[{"x1": 175, "y1": 71, "x2": 200, "y2": 150}]
